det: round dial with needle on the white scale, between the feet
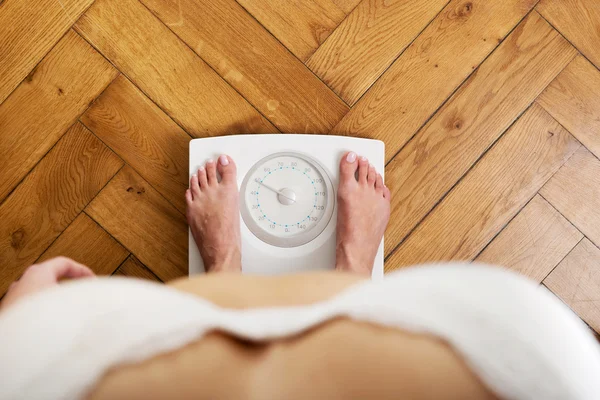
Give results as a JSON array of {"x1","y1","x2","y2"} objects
[{"x1": 240, "y1": 153, "x2": 335, "y2": 247}]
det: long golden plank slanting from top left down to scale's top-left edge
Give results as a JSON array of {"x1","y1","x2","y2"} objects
[{"x1": 75, "y1": 0, "x2": 277, "y2": 137}]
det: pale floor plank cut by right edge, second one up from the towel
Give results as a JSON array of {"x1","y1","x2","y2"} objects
[{"x1": 540, "y1": 147, "x2": 600, "y2": 245}]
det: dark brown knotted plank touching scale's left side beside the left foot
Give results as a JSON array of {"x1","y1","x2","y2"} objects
[{"x1": 85, "y1": 166, "x2": 188, "y2": 282}]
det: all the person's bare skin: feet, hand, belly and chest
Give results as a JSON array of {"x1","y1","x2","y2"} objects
[{"x1": 0, "y1": 153, "x2": 495, "y2": 400}]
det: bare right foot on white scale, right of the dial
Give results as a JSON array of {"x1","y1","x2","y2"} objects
[{"x1": 335, "y1": 152, "x2": 390, "y2": 275}]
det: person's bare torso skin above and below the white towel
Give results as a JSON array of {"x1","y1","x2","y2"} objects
[{"x1": 89, "y1": 271, "x2": 495, "y2": 400}]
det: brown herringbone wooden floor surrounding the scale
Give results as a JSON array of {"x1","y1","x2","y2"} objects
[{"x1": 0, "y1": 0, "x2": 600, "y2": 331}]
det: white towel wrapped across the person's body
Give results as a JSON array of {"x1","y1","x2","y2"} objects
[{"x1": 0, "y1": 264, "x2": 600, "y2": 400}]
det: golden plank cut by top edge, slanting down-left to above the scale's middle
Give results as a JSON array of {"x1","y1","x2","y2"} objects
[{"x1": 306, "y1": 0, "x2": 448, "y2": 105}]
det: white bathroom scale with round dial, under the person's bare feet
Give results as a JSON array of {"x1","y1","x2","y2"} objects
[{"x1": 189, "y1": 134, "x2": 385, "y2": 279}]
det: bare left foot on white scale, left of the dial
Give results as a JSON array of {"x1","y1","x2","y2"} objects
[{"x1": 185, "y1": 155, "x2": 242, "y2": 272}]
